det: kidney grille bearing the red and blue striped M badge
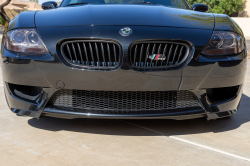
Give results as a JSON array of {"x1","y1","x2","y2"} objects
[{"x1": 130, "y1": 41, "x2": 191, "y2": 71}]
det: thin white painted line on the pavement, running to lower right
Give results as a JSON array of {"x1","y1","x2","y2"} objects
[{"x1": 121, "y1": 120, "x2": 250, "y2": 162}]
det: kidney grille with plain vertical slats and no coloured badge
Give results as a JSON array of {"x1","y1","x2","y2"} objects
[{"x1": 61, "y1": 40, "x2": 122, "y2": 70}]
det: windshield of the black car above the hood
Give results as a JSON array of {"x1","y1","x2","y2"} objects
[{"x1": 61, "y1": 0, "x2": 188, "y2": 9}]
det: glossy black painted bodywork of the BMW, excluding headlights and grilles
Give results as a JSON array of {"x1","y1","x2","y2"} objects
[{"x1": 1, "y1": 1, "x2": 246, "y2": 119}]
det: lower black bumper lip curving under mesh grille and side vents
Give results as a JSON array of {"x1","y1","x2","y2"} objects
[{"x1": 4, "y1": 83, "x2": 243, "y2": 120}]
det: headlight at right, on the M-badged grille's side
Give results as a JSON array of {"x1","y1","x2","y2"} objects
[{"x1": 202, "y1": 31, "x2": 244, "y2": 56}]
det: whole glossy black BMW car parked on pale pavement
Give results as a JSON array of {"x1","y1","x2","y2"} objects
[{"x1": 1, "y1": 0, "x2": 247, "y2": 120}]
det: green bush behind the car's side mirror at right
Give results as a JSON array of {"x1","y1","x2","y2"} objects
[{"x1": 187, "y1": 0, "x2": 245, "y2": 16}]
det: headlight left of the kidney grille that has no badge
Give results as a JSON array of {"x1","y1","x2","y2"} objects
[{"x1": 4, "y1": 29, "x2": 49, "y2": 55}]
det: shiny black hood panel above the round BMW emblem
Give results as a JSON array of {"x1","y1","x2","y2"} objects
[{"x1": 35, "y1": 4, "x2": 214, "y2": 29}]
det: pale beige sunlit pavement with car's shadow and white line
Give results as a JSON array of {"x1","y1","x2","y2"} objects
[{"x1": 0, "y1": 29, "x2": 250, "y2": 166}]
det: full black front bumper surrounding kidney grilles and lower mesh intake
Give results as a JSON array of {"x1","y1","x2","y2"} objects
[{"x1": 1, "y1": 26, "x2": 247, "y2": 119}]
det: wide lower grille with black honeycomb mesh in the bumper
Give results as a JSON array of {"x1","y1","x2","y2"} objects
[{"x1": 47, "y1": 90, "x2": 201, "y2": 114}]
